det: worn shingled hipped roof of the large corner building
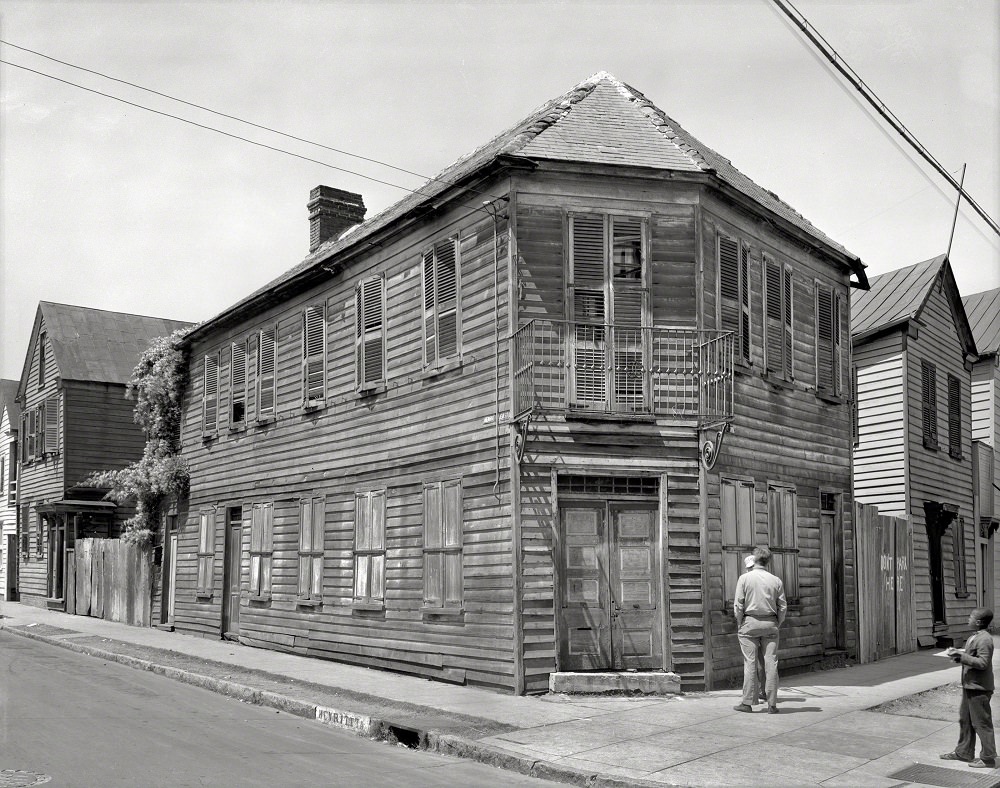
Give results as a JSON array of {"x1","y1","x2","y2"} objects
[{"x1": 192, "y1": 71, "x2": 864, "y2": 336}]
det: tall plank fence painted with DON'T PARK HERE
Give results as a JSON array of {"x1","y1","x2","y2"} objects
[{"x1": 854, "y1": 503, "x2": 916, "y2": 663}]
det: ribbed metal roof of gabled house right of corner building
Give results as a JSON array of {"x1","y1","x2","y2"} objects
[{"x1": 851, "y1": 255, "x2": 947, "y2": 337}]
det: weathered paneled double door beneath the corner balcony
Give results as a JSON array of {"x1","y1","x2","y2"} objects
[{"x1": 559, "y1": 501, "x2": 663, "y2": 671}]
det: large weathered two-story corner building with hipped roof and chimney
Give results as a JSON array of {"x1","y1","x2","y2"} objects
[{"x1": 174, "y1": 73, "x2": 866, "y2": 693}]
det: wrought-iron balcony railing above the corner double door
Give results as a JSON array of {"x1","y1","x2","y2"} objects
[{"x1": 510, "y1": 318, "x2": 733, "y2": 424}]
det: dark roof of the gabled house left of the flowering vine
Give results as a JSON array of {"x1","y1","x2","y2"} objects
[{"x1": 38, "y1": 301, "x2": 191, "y2": 384}]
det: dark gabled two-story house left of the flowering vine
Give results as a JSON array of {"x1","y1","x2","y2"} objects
[{"x1": 17, "y1": 301, "x2": 189, "y2": 609}]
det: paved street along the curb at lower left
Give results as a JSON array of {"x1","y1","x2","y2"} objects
[{"x1": 0, "y1": 631, "x2": 551, "y2": 788}]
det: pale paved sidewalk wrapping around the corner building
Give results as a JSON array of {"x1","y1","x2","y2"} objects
[{"x1": 0, "y1": 602, "x2": 1000, "y2": 788}]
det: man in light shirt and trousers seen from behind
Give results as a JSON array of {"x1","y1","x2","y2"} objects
[{"x1": 733, "y1": 547, "x2": 788, "y2": 714}]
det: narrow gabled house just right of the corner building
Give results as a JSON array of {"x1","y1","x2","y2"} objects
[{"x1": 851, "y1": 255, "x2": 981, "y2": 649}]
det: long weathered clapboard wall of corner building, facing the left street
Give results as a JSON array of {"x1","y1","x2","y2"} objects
[{"x1": 176, "y1": 189, "x2": 514, "y2": 690}]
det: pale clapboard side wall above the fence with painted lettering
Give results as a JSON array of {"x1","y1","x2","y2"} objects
[{"x1": 854, "y1": 332, "x2": 909, "y2": 516}]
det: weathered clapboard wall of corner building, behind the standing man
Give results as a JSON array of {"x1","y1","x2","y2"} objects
[{"x1": 701, "y1": 191, "x2": 856, "y2": 686}]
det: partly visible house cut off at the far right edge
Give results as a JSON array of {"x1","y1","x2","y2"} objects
[{"x1": 962, "y1": 288, "x2": 1000, "y2": 610}]
